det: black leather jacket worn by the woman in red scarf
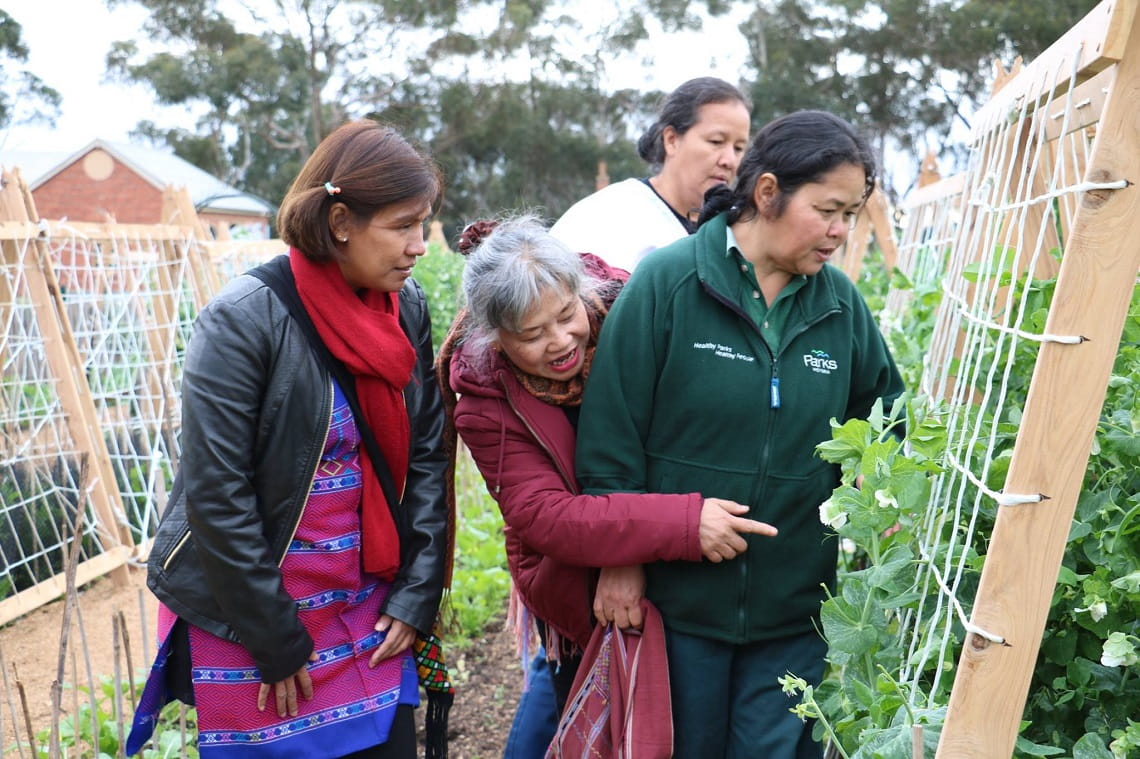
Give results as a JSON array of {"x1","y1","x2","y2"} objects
[{"x1": 147, "y1": 258, "x2": 447, "y2": 683}]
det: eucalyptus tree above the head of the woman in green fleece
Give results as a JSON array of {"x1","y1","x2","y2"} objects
[{"x1": 741, "y1": 0, "x2": 1097, "y2": 193}]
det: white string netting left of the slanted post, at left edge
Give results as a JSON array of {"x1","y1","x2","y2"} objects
[{"x1": 0, "y1": 237, "x2": 107, "y2": 598}]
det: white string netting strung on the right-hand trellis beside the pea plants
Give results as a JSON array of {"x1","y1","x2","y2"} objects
[{"x1": 888, "y1": 45, "x2": 1125, "y2": 708}]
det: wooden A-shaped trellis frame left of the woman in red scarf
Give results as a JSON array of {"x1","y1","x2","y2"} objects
[{"x1": 0, "y1": 170, "x2": 286, "y2": 625}]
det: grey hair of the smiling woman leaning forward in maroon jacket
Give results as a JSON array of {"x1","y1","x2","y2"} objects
[{"x1": 463, "y1": 214, "x2": 597, "y2": 358}]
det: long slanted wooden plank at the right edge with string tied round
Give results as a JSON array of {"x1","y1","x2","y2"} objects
[{"x1": 937, "y1": 4, "x2": 1140, "y2": 759}]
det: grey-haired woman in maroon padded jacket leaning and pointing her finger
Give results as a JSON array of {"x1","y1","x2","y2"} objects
[{"x1": 437, "y1": 217, "x2": 775, "y2": 729}]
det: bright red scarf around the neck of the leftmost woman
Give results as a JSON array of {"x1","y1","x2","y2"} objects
[{"x1": 288, "y1": 248, "x2": 416, "y2": 580}]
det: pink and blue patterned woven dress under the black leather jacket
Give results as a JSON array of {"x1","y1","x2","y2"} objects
[{"x1": 132, "y1": 387, "x2": 419, "y2": 759}]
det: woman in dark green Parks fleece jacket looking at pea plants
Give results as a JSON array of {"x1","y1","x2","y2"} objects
[{"x1": 577, "y1": 111, "x2": 903, "y2": 759}]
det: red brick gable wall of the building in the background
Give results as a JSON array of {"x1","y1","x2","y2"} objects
[{"x1": 32, "y1": 150, "x2": 162, "y2": 225}]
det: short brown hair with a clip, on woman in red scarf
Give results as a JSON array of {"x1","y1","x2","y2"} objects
[{"x1": 277, "y1": 119, "x2": 443, "y2": 262}]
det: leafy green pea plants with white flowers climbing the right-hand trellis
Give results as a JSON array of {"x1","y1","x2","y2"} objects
[{"x1": 785, "y1": 270, "x2": 1140, "y2": 759}]
